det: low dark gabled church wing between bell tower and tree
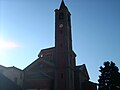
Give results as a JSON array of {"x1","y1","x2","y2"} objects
[{"x1": 75, "y1": 64, "x2": 97, "y2": 90}]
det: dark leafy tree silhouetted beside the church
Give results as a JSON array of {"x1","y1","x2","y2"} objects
[{"x1": 98, "y1": 61, "x2": 120, "y2": 90}]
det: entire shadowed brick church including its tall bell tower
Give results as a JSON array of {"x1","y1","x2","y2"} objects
[{"x1": 0, "y1": 0, "x2": 97, "y2": 90}]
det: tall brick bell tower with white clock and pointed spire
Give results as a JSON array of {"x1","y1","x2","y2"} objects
[{"x1": 55, "y1": 0, "x2": 75, "y2": 90}]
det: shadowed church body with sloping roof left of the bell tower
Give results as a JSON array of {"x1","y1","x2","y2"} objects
[{"x1": 24, "y1": 47, "x2": 55, "y2": 90}]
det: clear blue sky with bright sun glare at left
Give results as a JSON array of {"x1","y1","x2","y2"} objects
[{"x1": 0, "y1": 0, "x2": 120, "y2": 82}]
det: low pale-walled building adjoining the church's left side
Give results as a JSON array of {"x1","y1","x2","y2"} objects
[{"x1": 0, "y1": 65, "x2": 24, "y2": 88}]
